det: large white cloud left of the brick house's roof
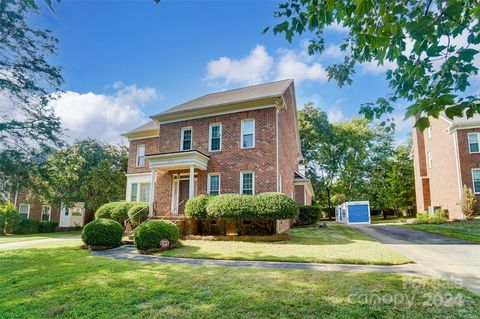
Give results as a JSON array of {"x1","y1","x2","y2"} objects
[{"x1": 51, "y1": 82, "x2": 162, "y2": 143}]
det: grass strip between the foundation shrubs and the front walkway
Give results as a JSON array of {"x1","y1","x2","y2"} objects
[{"x1": 160, "y1": 225, "x2": 412, "y2": 265}]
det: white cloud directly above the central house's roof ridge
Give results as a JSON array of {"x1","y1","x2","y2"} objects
[{"x1": 205, "y1": 45, "x2": 273, "y2": 85}]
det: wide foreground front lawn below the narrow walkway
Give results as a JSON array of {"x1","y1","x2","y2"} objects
[{"x1": 0, "y1": 248, "x2": 480, "y2": 319}]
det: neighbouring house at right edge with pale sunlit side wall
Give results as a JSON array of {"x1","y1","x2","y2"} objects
[{"x1": 413, "y1": 115, "x2": 480, "y2": 219}]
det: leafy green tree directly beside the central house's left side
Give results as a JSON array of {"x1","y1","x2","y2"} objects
[{"x1": 42, "y1": 139, "x2": 128, "y2": 212}]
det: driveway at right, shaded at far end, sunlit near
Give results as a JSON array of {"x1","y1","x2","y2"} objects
[{"x1": 352, "y1": 225, "x2": 480, "y2": 294}]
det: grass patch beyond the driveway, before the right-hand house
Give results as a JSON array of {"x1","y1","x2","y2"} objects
[{"x1": 404, "y1": 220, "x2": 480, "y2": 243}]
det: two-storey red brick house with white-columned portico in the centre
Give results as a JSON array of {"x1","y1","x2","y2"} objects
[{"x1": 124, "y1": 80, "x2": 313, "y2": 231}]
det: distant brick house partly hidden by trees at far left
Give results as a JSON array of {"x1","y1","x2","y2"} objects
[{"x1": 11, "y1": 192, "x2": 85, "y2": 227}]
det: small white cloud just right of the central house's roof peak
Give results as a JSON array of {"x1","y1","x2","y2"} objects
[{"x1": 275, "y1": 50, "x2": 328, "y2": 83}]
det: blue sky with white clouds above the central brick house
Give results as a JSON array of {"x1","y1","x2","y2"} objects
[{"x1": 32, "y1": 0, "x2": 409, "y2": 142}]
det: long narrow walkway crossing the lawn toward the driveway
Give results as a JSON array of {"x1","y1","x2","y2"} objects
[{"x1": 92, "y1": 246, "x2": 439, "y2": 277}]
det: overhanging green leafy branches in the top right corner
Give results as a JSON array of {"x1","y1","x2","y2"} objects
[{"x1": 265, "y1": 0, "x2": 480, "y2": 129}]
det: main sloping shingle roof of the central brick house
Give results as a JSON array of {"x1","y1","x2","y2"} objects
[{"x1": 151, "y1": 79, "x2": 293, "y2": 118}]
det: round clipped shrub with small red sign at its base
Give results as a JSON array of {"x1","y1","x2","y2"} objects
[{"x1": 133, "y1": 220, "x2": 180, "y2": 250}]
